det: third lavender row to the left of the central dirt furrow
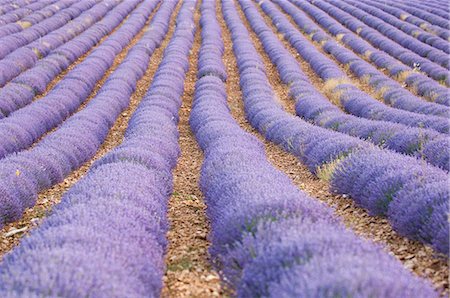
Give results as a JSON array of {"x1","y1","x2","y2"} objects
[{"x1": 0, "y1": 0, "x2": 160, "y2": 158}]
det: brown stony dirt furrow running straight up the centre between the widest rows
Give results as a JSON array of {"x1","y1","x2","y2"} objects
[{"x1": 163, "y1": 0, "x2": 221, "y2": 297}]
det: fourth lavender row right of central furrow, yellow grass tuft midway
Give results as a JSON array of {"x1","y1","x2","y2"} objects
[{"x1": 258, "y1": 1, "x2": 450, "y2": 133}]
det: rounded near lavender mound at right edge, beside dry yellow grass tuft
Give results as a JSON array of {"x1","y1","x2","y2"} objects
[{"x1": 330, "y1": 149, "x2": 450, "y2": 255}]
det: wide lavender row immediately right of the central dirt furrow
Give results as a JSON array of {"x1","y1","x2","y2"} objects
[{"x1": 190, "y1": 1, "x2": 436, "y2": 297}]
